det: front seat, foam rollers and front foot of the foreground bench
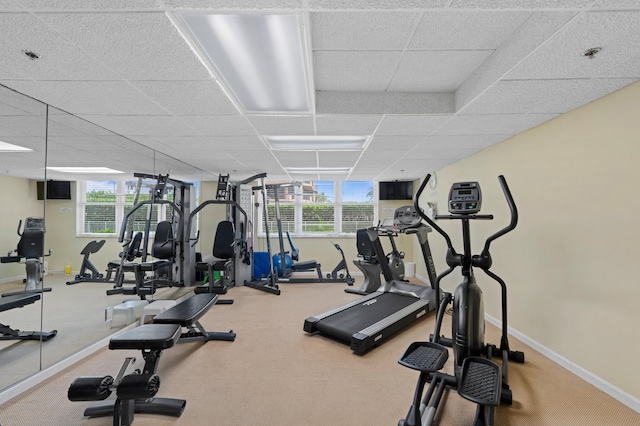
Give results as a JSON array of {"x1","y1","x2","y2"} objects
[{"x1": 67, "y1": 324, "x2": 187, "y2": 426}]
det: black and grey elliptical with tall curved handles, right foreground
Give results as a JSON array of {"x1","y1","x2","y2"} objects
[{"x1": 398, "y1": 175, "x2": 524, "y2": 426}]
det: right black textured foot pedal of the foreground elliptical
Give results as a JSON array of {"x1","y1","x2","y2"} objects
[{"x1": 458, "y1": 357, "x2": 502, "y2": 406}]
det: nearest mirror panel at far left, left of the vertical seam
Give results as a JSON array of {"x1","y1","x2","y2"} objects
[{"x1": 0, "y1": 86, "x2": 47, "y2": 389}]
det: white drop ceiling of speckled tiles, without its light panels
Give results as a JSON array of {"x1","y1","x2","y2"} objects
[{"x1": 0, "y1": 0, "x2": 640, "y2": 180}]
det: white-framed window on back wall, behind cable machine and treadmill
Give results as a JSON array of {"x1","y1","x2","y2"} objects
[{"x1": 259, "y1": 180, "x2": 376, "y2": 235}]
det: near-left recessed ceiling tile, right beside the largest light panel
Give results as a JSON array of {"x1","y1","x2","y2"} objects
[{"x1": 310, "y1": 12, "x2": 420, "y2": 50}]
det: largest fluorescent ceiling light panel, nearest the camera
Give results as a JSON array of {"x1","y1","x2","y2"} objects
[{"x1": 181, "y1": 14, "x2": 311, "y2": 113}]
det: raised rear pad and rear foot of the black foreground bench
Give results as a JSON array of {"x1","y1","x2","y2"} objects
[{"x1": 153, "y1": 293, "x2": 236, "y2": 343}]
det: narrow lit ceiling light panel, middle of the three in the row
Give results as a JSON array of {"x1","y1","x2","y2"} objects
[{"x1": 265, "y1": 136, "x2": 368, "y2": 151}]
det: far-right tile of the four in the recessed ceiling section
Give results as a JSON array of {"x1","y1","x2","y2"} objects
[{"x1": 389, "y1": 50, "x2": 493, "y2": 92}]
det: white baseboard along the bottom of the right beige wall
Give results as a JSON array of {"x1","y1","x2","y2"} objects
[{"x1": 485, "y1": 314, "x2": 640, "y2": 413}]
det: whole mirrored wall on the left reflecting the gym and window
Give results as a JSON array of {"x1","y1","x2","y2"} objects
[{"x1": 0, "y1": 86, "x2": 211, "y2": 390}]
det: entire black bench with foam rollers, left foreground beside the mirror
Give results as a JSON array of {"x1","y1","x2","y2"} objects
[{"x1": 67, "y1": 293, "x2": 236, "y2": 426}]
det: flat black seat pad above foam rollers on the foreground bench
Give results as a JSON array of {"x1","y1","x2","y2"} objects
[{"x1": 109, "y1": 324, "x2": 182, "y2": 350}]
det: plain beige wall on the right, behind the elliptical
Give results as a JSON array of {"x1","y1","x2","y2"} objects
[{"x1": 418, "y1": 83, "x2": 640, "y2": 401}]
